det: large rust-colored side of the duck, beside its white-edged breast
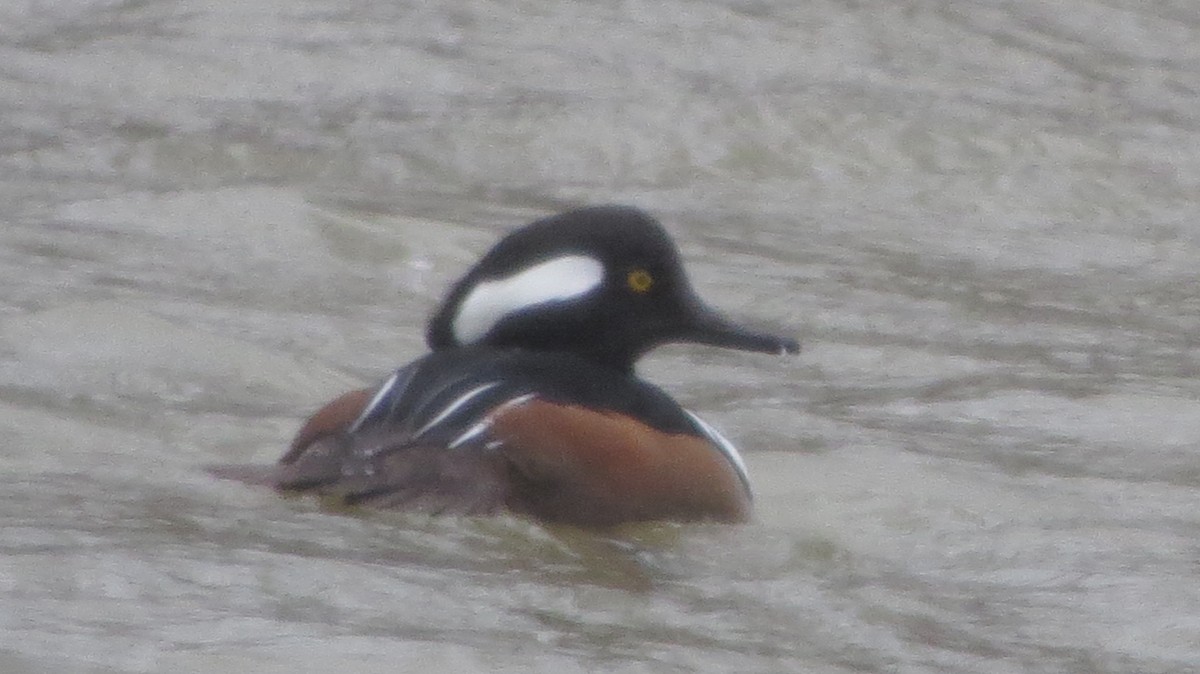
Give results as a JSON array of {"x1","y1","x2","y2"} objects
[{"x1": 493, "y1": 399, "x2": 751, "y2": 525}]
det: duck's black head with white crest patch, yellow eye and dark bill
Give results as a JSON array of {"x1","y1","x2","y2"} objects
[{"x1": 426, "y1": 206, "x2": 799, "y2": 371}]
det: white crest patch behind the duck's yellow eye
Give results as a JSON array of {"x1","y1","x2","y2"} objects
[{"x1": 451, "y1": 255, "x2": 604, "y2": 345}]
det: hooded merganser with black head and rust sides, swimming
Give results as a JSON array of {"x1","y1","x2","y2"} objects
[{"x1": 214, "y1": 206, "x2": 799, "y2": 525}]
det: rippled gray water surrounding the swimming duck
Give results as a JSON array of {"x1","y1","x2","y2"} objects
[{"x1": 0, "y1": 0, "x2": 1200, "y2": 673}]
